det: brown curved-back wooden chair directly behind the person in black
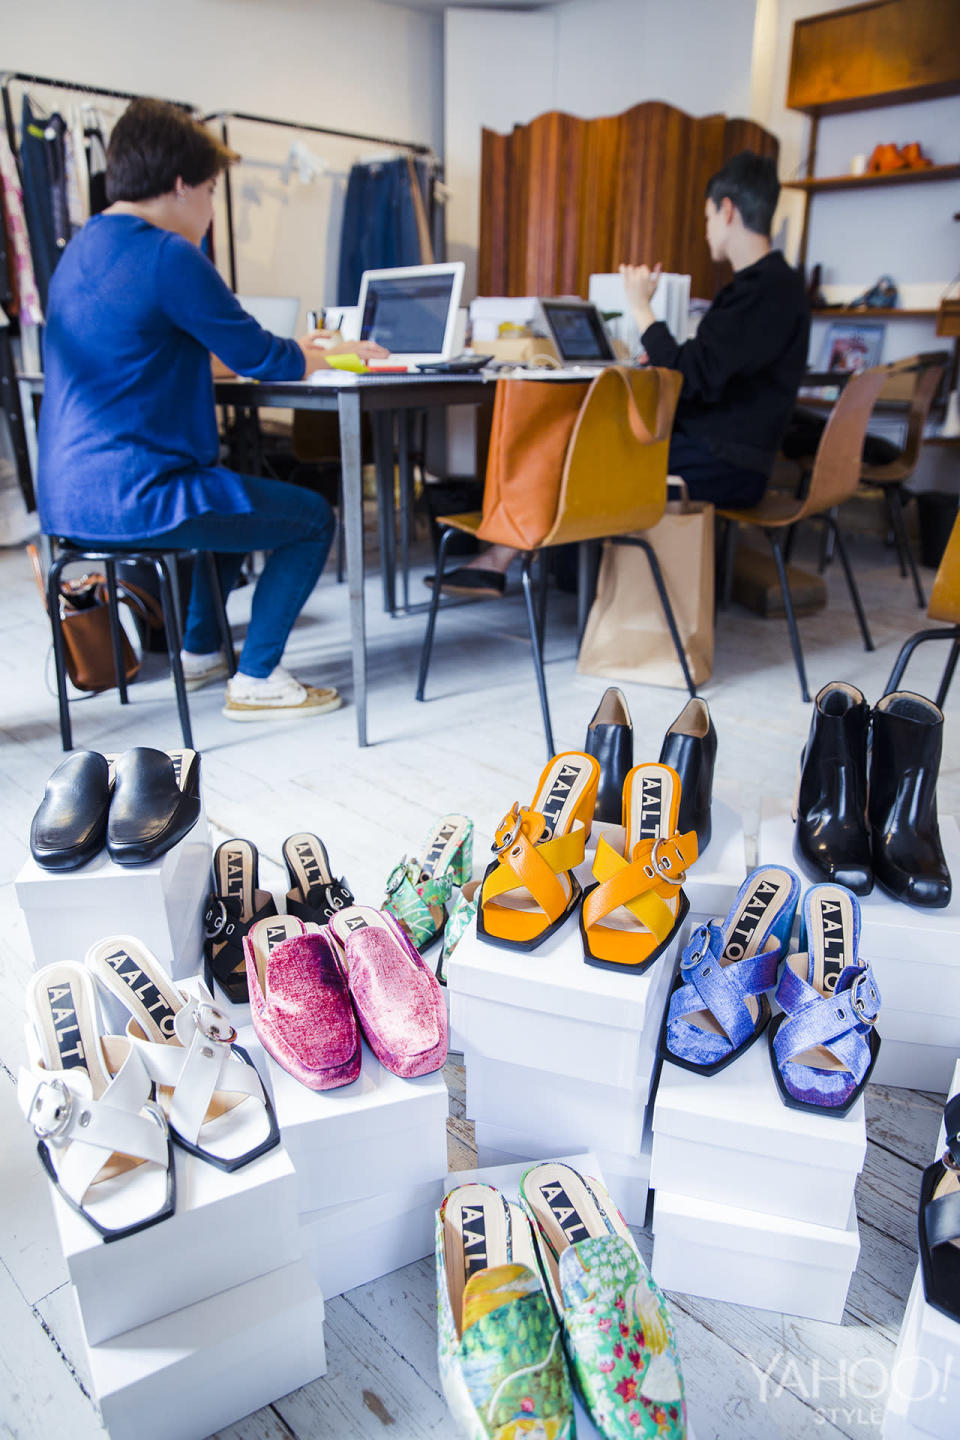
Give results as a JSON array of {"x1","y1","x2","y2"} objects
[{"x1": 717, "y1": 367, "x2": 887, "y2": 703}]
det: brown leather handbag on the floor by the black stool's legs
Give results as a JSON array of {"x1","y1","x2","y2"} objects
[{"x1": 27, "y1": 544, "x2": 163, "y2": 693}]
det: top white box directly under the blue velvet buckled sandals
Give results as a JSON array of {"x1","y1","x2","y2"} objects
[{"x1": 651, "y1": 1034, "x2": 866, "y2": 1227}]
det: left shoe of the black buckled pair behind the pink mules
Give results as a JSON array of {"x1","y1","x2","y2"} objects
[{"x1": 203, "y1": 840, "x2": 276, "y2": 1005}]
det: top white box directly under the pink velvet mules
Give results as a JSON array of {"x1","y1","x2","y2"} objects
[{"x1": 254, "y1": 1030, "x2": 449, "y2": 1214}]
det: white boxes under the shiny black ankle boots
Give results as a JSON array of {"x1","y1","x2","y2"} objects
[{"x1": 759, "y1": 799, "x2": 960, "y2": 1092}]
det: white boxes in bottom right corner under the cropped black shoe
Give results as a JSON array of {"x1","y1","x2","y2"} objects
[{"x1": 882, "y1": 1061, "x2": 960, "y2": 1440}]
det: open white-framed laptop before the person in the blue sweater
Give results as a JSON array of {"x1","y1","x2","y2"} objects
[{"x1": 357, "y1": 261, "x2": 466, "y2": 369}]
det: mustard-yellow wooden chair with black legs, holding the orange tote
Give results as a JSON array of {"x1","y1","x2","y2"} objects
[{"x1": 416, "y1": 367, "x2": 697, "y2": 756}]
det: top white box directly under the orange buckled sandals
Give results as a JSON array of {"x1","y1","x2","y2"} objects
[{"x1": 448, "y1": 910, "x2": 684, "y2": 1094}]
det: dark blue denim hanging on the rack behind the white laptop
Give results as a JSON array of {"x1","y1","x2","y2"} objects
[{"x1": 337, "y1": 156, "x2": 423, "y2": 305}]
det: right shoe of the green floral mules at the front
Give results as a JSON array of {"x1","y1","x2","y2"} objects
[{"x1": 520, "y1": 1161, "x2": 687, "y2": 1440}]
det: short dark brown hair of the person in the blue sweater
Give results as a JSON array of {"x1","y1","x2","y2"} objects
[{"x1": 107, "y1": 99, "x2": 239, "y2": 203}]
